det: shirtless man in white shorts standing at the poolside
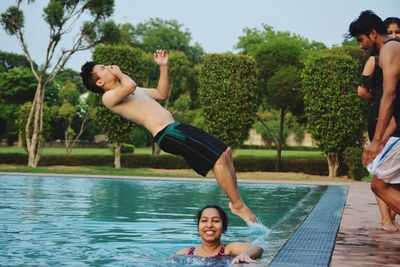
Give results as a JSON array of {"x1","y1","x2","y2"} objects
[{"x1": 348, "y1": 10, "x2": 400, "y2": 213}]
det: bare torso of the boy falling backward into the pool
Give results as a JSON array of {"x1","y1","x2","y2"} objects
[{"x1": 102, "y1": 87, "x2": 174, "y2": 136}]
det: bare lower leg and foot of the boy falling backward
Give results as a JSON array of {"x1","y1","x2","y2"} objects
[{"x1": 213, "y1": 147, "x2": 257, "y2": 223}]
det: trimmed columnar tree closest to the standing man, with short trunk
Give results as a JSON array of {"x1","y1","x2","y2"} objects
[{"x1": 302, "y1": 50, "x2": 364, "y2": 177}]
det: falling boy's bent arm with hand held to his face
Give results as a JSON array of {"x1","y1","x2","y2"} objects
[{"x1": 103, "y1": 65, "x2": 136, "y2": 108}]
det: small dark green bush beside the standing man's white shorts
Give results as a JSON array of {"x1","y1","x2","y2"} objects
[{"x1": 344, "y1": 147, "x2": 368, "y2": 181}]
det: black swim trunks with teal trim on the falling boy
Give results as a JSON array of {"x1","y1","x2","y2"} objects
[{"x1": 154, "y1": 122, "x2": 228, "y2": 176}]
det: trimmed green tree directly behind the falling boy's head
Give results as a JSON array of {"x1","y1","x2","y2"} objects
[{"x1": 93, "y1": 45, "x2": 146, "y2": 168}]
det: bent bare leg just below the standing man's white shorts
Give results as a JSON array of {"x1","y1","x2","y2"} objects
[{"x1": 371, "y1": 176, "x2": 400, "y2": 214}]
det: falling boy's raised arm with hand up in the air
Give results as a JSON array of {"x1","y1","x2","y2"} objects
[{"x1": 143, "y1": 50, "x2": 169, "y2": 100}]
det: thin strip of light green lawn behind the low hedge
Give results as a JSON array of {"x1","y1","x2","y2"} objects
[{"x1": 0, "y1": 147, "x2": 325, "y2": 159}]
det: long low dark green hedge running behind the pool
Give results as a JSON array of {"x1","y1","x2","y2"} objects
[{"x1": 0, "y1": 153, "x2": 347, "y2": 175}]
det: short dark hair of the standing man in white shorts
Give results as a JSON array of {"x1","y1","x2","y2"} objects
[{"x1": 346, "y1": 10, "x2": 387, "y2": 38}]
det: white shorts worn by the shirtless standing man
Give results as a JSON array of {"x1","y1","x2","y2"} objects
[{"x1": 367, "y1": 137, "x2": 400, "y2": 184}]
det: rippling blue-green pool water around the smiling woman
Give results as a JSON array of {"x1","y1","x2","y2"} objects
[{"x1": 0, "y1": 175, "x2": 326, "y2": 267}]
